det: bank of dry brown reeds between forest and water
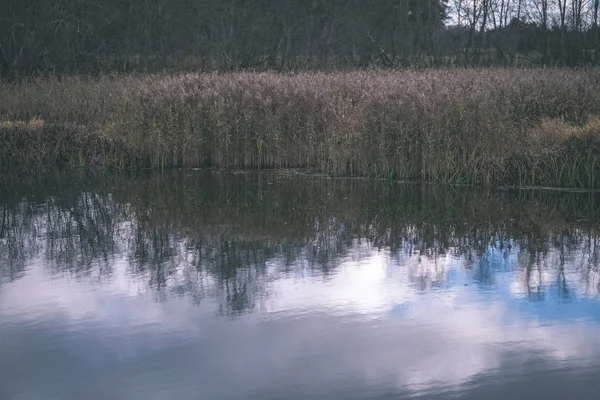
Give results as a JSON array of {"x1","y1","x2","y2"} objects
[{"x1": 0, "y1": 69, "x2": 600, "y2": 187}]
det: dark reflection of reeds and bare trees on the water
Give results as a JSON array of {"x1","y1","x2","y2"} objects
[{"x1": 0, "y1": 171, "x2": 600, "y2": 315}]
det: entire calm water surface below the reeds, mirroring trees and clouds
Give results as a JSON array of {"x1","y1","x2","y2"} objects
[{"x1": 0, "y1": 171, "x2": 600, "y2": 400}]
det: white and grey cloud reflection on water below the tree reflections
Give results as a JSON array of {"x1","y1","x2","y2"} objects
[{"x1": 0, "y1": 244, "x2": 600, "y2": 398}]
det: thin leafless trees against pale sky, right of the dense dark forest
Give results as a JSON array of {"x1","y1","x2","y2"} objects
[{"x1": 449, "y1": 0, "x2": 600, "y2": 66}]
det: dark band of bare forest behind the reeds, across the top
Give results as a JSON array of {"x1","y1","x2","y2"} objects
[{"x1": 0, "y1": 0, "x2": 600, "y2": 79}]
